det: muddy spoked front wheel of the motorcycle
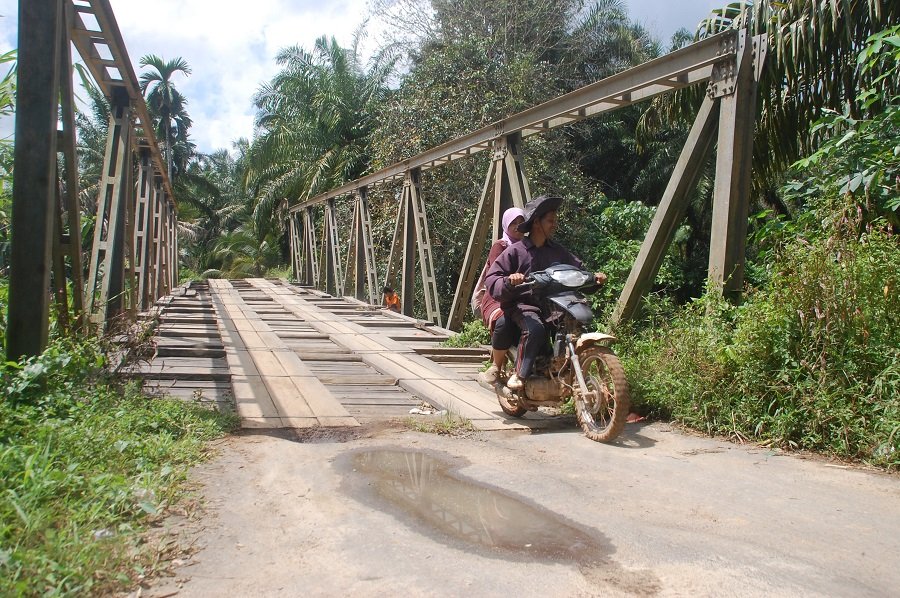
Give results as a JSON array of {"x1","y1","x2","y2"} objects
[{"x1": 575, "y1": 347, "x2": 631, "y2": 442}]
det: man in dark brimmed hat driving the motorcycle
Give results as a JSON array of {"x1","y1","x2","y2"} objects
[{"x1": 485, "y1": 195, "x2": 606, "y2": 392}]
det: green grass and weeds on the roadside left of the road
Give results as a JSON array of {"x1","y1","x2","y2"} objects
[{"x1": 0, "y1": 341, "x2": 231, "y2": 596}]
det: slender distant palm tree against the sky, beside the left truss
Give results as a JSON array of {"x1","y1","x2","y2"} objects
[{"x1": 140, "y1": 54, "x2": 191, "y2": 179}]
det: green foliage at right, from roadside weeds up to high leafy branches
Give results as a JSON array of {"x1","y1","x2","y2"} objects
[{"x1": 626, "y1": 27, "x2": 900, "y2": 469}]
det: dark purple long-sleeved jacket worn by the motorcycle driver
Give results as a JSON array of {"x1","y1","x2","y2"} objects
[{"x1": 484, "y1": 237, "x2": 584, "y2": 312}]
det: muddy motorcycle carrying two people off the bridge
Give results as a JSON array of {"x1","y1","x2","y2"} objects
[{"x1": 494, "y1": 264, "x2": 631, "y2": 442}]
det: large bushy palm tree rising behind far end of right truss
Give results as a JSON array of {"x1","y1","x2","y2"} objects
[{"x1": 245, "y1": 36, "x2": 393, "y2": 237}]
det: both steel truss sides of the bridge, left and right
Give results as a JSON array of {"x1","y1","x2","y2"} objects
[{"x1": 7, "y1": 0, "x2": 767, "y2": 366}]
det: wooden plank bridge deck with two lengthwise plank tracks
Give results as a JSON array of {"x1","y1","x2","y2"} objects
[{"x1": 138, "y1": 278, "x2": 548, "y2": 430}]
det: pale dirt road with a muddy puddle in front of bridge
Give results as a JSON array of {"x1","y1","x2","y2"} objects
[{"x1": 142, "y1": 424, "x2": 900, "y2": 597}]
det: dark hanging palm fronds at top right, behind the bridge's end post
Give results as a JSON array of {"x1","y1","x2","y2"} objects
[{"x1": 644, "y1": 0, "x2": 900, "y2": 192}]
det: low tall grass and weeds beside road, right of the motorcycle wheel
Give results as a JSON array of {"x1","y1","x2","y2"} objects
[{"x1": 624, "y1": 213, "x2": 900, "y2": 469}]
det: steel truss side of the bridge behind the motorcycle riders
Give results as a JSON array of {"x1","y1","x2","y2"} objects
[{"x1": 290, "y1": 30, "x2": 767, "y2": 329}]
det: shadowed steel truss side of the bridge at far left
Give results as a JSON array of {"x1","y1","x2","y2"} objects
[{"x1": 7, "y1": 0, "x2": 178, "y2": 359}]
